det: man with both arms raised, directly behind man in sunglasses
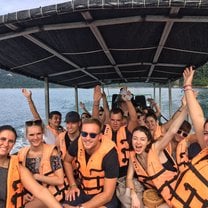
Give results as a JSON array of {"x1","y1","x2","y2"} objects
[{"x1": 93, "y1": 86, "x2": 137, "y2": 178}]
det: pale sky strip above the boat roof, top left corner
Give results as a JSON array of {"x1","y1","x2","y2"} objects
[{"x1": 0, "y1": 0, "x2": 67, "y2": 15}]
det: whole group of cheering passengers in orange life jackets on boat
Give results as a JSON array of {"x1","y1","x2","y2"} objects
[{"x1": 0, "y1": 67, "x2": 208, "y2": 208}]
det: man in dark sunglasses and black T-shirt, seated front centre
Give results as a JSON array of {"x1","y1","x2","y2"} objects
[{"x1": 64, "y1": 118, "x2": 119, "y2": 208}]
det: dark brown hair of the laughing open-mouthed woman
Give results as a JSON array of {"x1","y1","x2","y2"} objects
[{"x1": 130, "y1": 126, "x2": 155, "y2": 153}]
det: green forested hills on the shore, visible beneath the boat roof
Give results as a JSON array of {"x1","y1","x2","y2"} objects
[{"x1": 0, "y1": 64, "x2": 208, "y2": 88}]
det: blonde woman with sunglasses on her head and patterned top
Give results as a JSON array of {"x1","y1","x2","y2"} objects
[{"x1": 18, "y1": 120, "x2": 66, "y2": 208}]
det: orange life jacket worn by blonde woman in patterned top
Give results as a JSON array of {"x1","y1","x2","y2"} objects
[{"x1": 18, "y1": 144, "x2": 69, "y2": 201}]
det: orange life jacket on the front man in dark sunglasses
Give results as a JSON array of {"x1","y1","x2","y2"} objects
[{"x1": 77, "y1": 138, "x2": 115, "y2": 194}]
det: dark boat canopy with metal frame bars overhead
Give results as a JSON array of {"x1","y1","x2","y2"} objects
[{"x1": 0, "y1": 0, "x2": 208, "y2": 88}]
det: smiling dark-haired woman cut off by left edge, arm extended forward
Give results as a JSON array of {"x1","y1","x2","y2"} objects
[{"x1": 0, "y1": 125, "x2": 61, "y2": 208}]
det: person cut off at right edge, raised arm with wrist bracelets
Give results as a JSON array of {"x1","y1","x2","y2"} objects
[{"x1": 171, "y1": 66, "x2": 208, "y2": 208}]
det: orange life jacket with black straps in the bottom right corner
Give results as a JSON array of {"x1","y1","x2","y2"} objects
[{"x1": 171, "y1": 147, "x2": 208, "y2": 208}]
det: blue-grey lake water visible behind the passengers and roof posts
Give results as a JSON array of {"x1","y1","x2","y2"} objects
[{"x1": 0, "y1": 88, "x2": 208, "y2": 154}]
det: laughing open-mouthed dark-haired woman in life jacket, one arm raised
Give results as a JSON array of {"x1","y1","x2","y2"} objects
[{"x1": 122, "y1": 100, "x2": 187, "y2": 207}]
